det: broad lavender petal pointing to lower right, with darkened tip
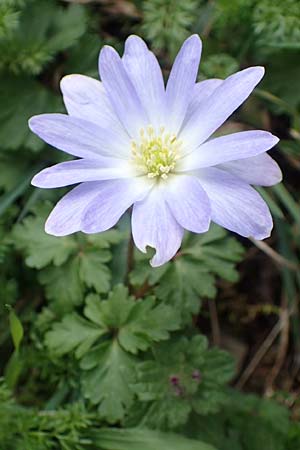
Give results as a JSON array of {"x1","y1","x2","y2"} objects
[{"x1": 198, "y1": 167, "x2": 273, "y2": 239}]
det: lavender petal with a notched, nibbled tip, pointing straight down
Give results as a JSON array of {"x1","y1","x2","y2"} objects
[{"x1": 132, "y1": 187, "x2": 183, "y2": 267}]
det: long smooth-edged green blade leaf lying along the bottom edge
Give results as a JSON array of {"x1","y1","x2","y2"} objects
[{"x1": 93, "y1": 428, "x2": 217, "y2": 450}]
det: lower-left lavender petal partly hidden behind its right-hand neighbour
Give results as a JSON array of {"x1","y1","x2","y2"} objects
[{"x1": 45, "y1": 181, "x2": 103, "y2": 236}]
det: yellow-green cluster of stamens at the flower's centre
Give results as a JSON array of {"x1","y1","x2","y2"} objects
[{"x1": 131, "y1": 125, "x2": 182, "y2": 179}]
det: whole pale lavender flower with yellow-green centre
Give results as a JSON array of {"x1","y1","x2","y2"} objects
[{"x1": 29, "y1": 35, "x2": 281, "y2": 266}]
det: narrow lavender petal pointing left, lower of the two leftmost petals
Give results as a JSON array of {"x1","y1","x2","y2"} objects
[{"x1": 31, "y1": 158, "x2": 132, "y2": 188}]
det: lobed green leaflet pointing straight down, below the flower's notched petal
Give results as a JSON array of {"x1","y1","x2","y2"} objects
[{"x1": 80, "y1": 340, "x2": 136, "y2": 423}]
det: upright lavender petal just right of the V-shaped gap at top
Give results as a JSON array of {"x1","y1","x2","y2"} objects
[{"x1": 166, "y1": 34, "x2": 202, "y2": 134}]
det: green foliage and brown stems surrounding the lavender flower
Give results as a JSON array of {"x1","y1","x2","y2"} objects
[{"x1": 0, "y1": 0, "x2": 300, "y2": 450}]
